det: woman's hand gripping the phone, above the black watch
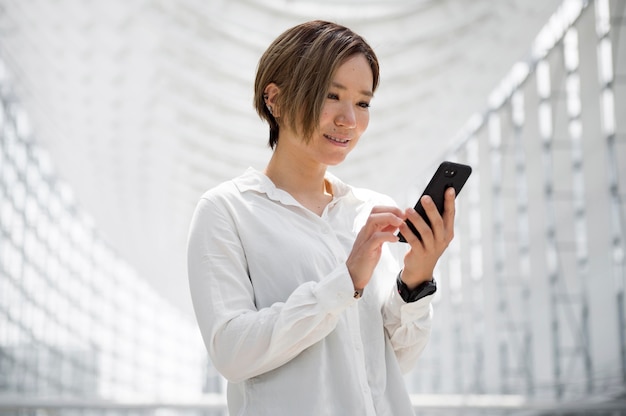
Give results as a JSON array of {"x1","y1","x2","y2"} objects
[{"x1": 400, "y1": 188, "x2": 455, "y2": 289}]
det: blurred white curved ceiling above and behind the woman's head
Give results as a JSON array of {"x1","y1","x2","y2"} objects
[{"x1": 0, "y1": 0, "x2": 562, "y2": 313}]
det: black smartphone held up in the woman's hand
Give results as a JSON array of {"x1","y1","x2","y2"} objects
[{"x1": 398, "y1": 161, "x2": 472, "y2": 243}]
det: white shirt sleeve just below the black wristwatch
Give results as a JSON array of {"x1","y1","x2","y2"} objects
[{"x1": 383, "y1": 284, "x2": 434, "y2": 374}]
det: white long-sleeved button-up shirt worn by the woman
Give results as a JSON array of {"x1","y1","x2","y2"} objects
[{"x1": 188, "y1": 169, "x2": 432, "y2": 416}]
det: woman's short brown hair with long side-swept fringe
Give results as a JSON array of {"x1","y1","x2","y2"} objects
[{"x1": 254, "y1": 20, "x2": 379, "y2": 149}]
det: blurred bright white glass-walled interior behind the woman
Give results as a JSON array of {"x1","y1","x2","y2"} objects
[{"x1": 0, "y1": 0, "x2": 626, "y2": 416}]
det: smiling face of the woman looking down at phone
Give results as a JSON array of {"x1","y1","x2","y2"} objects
[{"x1": 279, "y1": 54, "x2": 373, "y2": 166}]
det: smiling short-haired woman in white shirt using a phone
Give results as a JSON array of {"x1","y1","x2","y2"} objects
[{"x1": 188, "y1": 21, "x2": 454, "y2": 416}]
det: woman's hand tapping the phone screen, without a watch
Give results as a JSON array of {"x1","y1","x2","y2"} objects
[{"x1": 346, "y1": 206, "x2": 405, "y2": 290}]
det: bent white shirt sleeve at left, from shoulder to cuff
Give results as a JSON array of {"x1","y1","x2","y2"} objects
[{"x1": 188, "y1": 198, "x2": 356, "y2": 382}]
